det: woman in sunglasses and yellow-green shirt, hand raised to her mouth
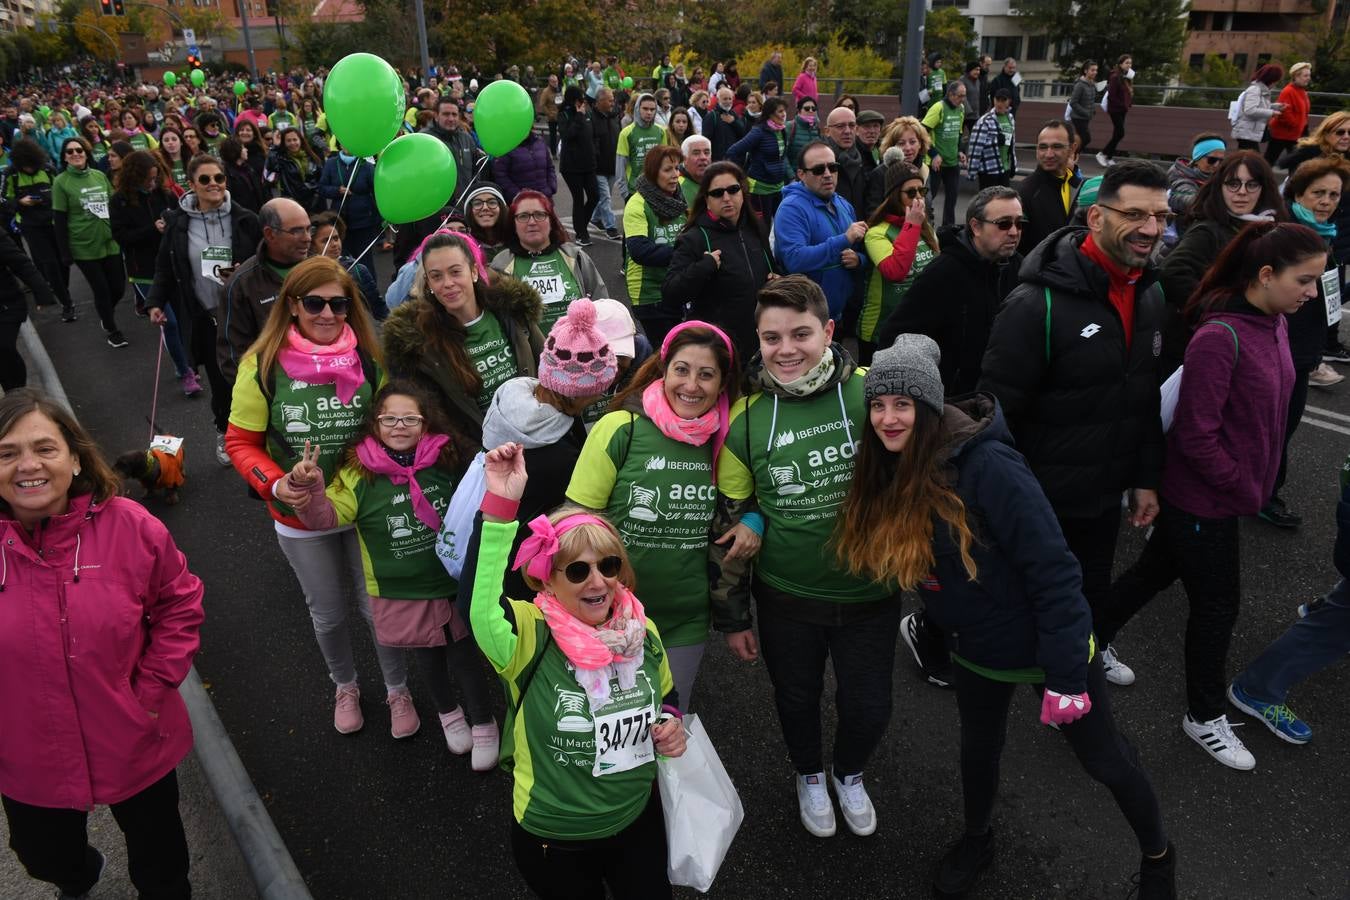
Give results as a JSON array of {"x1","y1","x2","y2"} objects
[{"x1": 857, "y1": 162, "x2": 938, "y2": 366}]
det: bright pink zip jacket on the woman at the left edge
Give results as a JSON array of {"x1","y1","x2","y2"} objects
[{"x1": 0, "y1": 494, "x2": 203, "y2": 810}]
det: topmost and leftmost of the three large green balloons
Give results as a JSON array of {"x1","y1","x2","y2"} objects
[{"x1": 324, "y1": 53, "x2": 402, "y2": 157}]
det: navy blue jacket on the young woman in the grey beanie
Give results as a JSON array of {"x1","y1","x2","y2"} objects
[{"x1": 919, "y1": 393, "x2": 1092, "y2": 694}]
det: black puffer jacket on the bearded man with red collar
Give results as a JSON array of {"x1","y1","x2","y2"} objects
[{"x1": 980, "y1": 228, "x2": 1164, "y2": 518}]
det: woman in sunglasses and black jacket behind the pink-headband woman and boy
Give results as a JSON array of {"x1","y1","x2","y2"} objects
[{"x1": 662, "y1": 161, "x2": 778, "y2": 359}]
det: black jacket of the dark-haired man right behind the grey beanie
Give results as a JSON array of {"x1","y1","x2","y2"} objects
[{"x1": 876, "y1": 227, "x2": 1022, "y2": 395}]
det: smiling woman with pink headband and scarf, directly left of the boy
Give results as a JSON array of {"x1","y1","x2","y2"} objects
[{"x1": 567, "y1": 320, "x2": 763, "y2": 708}]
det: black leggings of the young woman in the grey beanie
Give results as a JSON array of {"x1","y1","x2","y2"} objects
[{"x1": 952, "y1": 645, "x2": 1168, "y2": 855}]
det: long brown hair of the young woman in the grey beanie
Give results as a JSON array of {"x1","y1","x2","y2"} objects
[{"x1": 833, "y1": 402, "x2": 976, "y2": 591}]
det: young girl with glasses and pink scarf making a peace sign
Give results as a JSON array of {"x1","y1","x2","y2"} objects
[{"x1": 286, "y1": 382, "x2": 498, "y2": 772}]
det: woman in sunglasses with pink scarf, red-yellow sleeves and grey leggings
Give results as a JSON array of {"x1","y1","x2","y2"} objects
[{"x1": 225, "y1": 256, "x2": 421, "y2": 738}]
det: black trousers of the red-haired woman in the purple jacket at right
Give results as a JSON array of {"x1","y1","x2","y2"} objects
[{"x1": 1092, "y1": 501, "x2": 1242, "y2": 722}]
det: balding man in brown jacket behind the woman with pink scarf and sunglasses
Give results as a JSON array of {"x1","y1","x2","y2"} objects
[{"x1": 216, "y1": 197, "x2": 313, "y2": 385}]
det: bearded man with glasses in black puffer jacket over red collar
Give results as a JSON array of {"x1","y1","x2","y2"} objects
[{"x1": 979, "y1": 159, "x2": 1172, "y2": 684}]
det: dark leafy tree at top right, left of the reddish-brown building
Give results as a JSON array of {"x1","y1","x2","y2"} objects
[{"x1": 1017, "y1": 0, "x2": 1187, "y2": 84}]
